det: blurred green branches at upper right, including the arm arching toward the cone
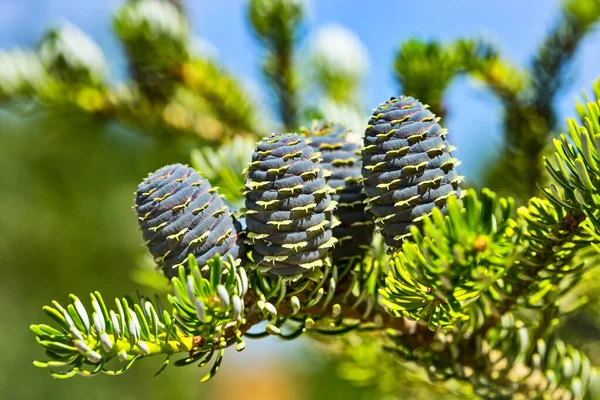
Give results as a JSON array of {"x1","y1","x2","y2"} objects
[{"x1": 394, "y1": 0, "x2": 600, "y2": 204}]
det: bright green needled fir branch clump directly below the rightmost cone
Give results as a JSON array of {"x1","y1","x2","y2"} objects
[{"x1": 381, "y1": 188, "x2": 596, "y2": 397}]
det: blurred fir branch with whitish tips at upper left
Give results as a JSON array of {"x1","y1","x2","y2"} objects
[{"x1": 0, "y1": 0, "x2": 260, "y2": 142}]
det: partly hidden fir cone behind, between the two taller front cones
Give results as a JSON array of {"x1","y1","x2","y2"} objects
[{"x1": 303, "y1": 121, "x2": 374, "y2": 263}]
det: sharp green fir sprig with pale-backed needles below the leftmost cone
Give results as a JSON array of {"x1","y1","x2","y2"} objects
[{"x1": 31, "y1": 257, "x2": 248, "y2": 380}]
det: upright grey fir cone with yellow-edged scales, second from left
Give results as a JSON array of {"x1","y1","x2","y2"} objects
[{"x1": 246, "y1": 134, "x2": 336, "y2": 277}]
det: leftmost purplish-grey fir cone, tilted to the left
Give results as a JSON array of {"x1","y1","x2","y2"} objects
[{"x1": 135, "y1": 164, "x2": 240, "y2": 278}]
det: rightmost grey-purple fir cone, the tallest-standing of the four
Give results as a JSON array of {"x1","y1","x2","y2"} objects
[{"x1": 362, "y1": 96, "x2": 462, "y2": 248}]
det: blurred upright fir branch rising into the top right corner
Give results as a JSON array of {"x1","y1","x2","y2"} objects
[{"x1": 480, "y1": 0, "x2": 600, "y2": 203}]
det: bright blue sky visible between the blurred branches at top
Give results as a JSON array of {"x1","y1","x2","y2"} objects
[{"x1": 0, "y1": 0, "x2": 600, "y2": 177}]
